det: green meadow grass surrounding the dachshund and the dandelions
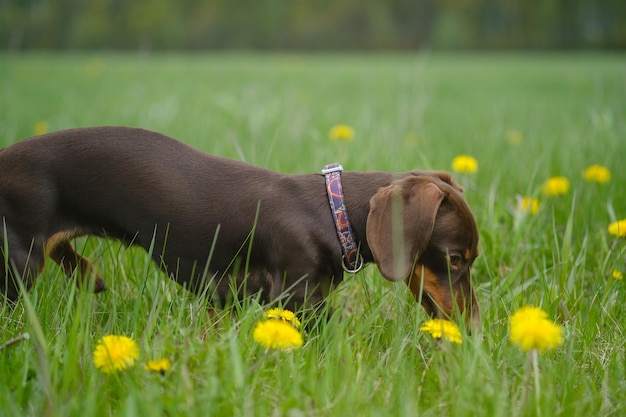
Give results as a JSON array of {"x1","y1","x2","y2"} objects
[{"x1": 0, "y1": 53, "x2": 626, "y2": 417}]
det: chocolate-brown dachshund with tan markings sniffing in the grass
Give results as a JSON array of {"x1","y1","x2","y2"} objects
[{"x1": 0, "y1": 127, "x2": 479, "y2": 322}]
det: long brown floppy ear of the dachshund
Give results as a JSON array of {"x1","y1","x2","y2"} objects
[{"x1": 366, "y1": 176, "x2": 445, "y2": 281}]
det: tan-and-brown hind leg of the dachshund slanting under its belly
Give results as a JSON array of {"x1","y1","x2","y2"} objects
[{"x1": 46, "y1": 238, "x2": 106, "y2": 293}]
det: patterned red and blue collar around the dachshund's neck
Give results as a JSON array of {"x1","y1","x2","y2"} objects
[{"x1": 322, "y1": 163, "x2": 363, "y2": 274}]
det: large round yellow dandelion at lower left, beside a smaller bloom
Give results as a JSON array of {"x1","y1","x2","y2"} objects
[{"x1": 93, "y1": 335, "x2": 139, "y2": 374}]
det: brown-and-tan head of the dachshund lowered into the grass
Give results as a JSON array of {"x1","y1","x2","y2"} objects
[{"x1": 367, "y1": 174, "x2": 480, "y2": 327}]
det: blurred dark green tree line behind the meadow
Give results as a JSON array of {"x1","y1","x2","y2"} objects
[{"x1": 0, "y1": 0, "x2": 626, "y2": 50}]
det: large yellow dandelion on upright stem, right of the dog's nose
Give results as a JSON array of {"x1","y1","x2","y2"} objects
[{"x1": 509, "y1": 306, "x2": 563, "y2": 353}]
